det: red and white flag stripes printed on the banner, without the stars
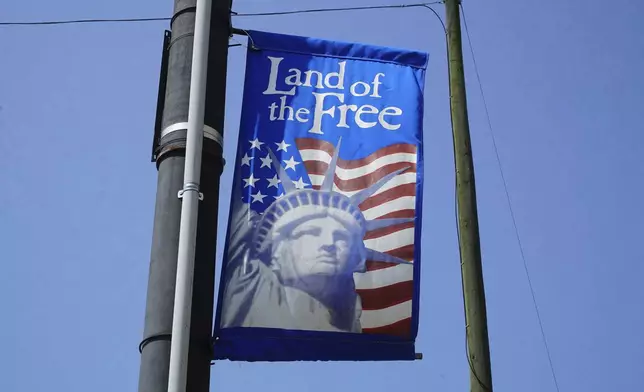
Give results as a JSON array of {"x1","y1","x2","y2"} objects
[{"x1": 296, "y1": 138, "x2": 417, "y2": 336}]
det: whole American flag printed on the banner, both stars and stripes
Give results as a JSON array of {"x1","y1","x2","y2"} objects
[{"x1": 236, "y1": 137, "x2": 417, "y2": 336}]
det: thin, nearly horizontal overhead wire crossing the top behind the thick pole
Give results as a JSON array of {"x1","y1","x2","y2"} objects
[{"x1": 0, "y1": 1, "x2": 442, "y2": 26}]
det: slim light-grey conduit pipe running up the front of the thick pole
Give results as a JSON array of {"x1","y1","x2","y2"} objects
[{"x1": 168, "y1": 0, "x2": 212, "y2": 392}]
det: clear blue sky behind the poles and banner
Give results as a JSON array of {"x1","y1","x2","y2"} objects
[{"x1": 0, "y1": 0, "x2": 644, "y2": 392}]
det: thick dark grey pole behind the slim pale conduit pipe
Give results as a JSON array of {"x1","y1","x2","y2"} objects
[{"x1": 139, "y1": 0, "x2": 230, "y2": 392}]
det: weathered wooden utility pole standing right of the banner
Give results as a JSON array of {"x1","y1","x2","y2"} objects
[{"x1": 445, "y1": 0, "x2": 492, "y2": 392}]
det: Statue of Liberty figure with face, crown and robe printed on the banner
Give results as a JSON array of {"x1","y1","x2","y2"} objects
[{"x1": 220, "y1": 141, "x2": 414, "y2": 333}]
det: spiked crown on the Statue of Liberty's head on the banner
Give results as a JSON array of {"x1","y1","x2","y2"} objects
[{"x1": 252, "y1": 139, "x2": 414, "y2": 264}]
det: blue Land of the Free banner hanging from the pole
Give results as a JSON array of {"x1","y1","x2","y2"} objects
[{"x1": 213, "y1": 31, "x2": 428, "y2": 361}]
